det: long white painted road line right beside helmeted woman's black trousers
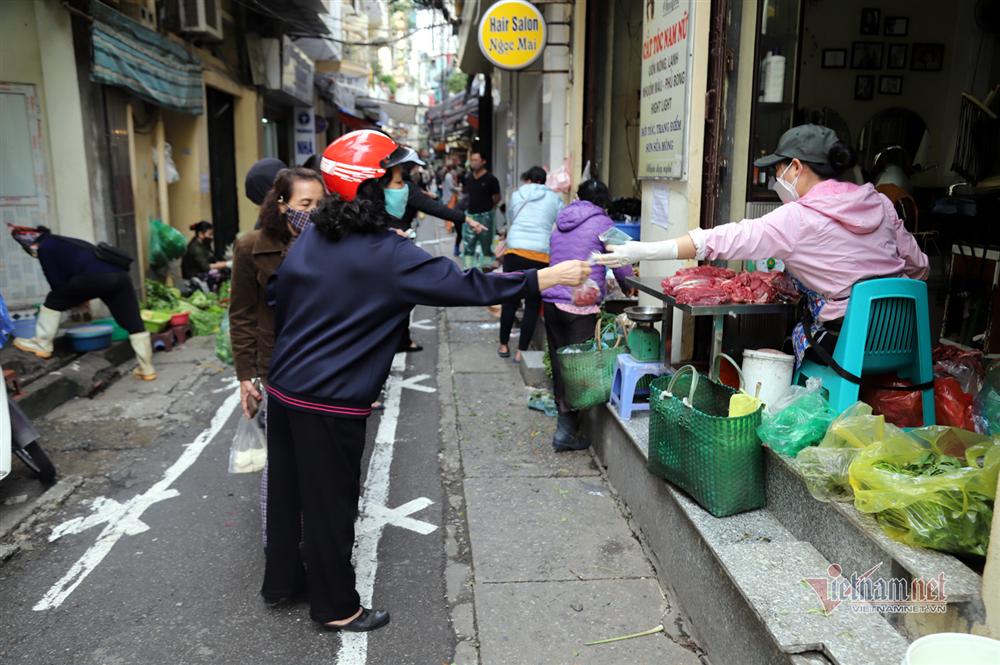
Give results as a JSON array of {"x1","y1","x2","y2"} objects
[{"x1": 336, "y1": 353, "x2": 406, "y2": 665}]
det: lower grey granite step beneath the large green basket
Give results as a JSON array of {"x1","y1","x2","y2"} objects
[{"x1": 585, "y1": 408, "x2": 908, "y2": 665}]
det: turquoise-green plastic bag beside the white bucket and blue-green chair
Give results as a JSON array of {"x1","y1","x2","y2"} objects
[{"x1": 757, "y1": 379, "x2": 834, "y2": 457}]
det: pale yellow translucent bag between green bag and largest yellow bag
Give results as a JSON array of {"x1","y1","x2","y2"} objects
[{"x1": 794, "y1": 402, "x2": 905, "y2": 501}]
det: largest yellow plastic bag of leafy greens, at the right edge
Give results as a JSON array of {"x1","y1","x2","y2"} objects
[{"x1": 849, "y1": 427, "x2": 1000, "y2": 556}]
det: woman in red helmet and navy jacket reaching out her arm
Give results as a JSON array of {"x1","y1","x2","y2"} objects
[{"x1": 261, "y1": 130, "x2": 590, "y2": 632}]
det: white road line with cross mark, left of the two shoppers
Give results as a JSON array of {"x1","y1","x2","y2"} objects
[{"x1": 33, "y1": 388, "x2": 240, "y2": 612}]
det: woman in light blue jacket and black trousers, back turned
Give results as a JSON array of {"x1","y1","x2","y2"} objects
[{"x1": 497, "y1": 166, "x2": 563, "y2": 363}]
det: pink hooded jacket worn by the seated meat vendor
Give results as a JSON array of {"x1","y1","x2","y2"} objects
[{"x1": 690, "y1": 180, "x2": 928, "y2": 321}]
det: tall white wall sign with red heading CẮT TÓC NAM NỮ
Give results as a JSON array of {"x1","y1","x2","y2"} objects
[{"x1": 639, "y1": 0, "x2": 693, "y2": 179}]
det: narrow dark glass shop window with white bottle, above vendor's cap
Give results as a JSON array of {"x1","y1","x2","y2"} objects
[{"x1": 747, "y1": 0, "x2": 802, "y2": 201}]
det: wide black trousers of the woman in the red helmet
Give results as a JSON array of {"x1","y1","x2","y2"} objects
[{"x1": 261, "y1": 399, "x2": 365, "y2": 623}]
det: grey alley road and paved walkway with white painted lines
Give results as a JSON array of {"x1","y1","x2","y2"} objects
[{"x1": 0, "y1": 220, "x2": 707, "y2": 665}]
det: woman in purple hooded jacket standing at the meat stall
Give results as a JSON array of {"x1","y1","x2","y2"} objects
[{"x1": 542, "y1": 179, "x2": 632, "y2": 452}]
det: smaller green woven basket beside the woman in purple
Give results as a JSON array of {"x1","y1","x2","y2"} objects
[{"x1": 556, "y1": 318, "x2": 628, "y2": 410}]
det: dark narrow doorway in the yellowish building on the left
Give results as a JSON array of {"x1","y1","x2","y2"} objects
[{"x1": 205, "y1": 88, "x2": 239, "y2": 257}]
